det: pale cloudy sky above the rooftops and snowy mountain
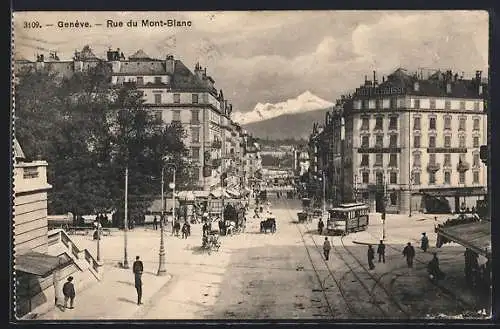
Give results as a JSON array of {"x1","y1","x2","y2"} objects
[{"x1": 13, "y1": 11, "x2": 488, "y2": 112}]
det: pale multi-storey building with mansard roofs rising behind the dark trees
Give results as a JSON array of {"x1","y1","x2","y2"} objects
[{"x1": 12, "y1": 46, "x2": 246, "y2": 190}]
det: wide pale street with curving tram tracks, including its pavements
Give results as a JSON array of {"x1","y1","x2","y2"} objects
[{"x1": 48, "y1": 200, "x2": 490, "y2": 320}]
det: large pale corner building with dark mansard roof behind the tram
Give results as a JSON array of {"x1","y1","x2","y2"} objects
[{"x1": 344, "y1": 69, "x2": 487, "y2": 213}]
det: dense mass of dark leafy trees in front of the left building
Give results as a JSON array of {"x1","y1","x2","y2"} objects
[{"x1": 15, "y1": 63, "x2": 191, "y2": 220}]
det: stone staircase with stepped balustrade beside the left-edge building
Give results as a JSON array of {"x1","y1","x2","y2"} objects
[{"x1": 48, "y1": 229, "x2": 102, "y2": 280}]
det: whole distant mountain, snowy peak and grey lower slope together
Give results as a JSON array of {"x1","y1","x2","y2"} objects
[{"x1": 233, "y1": 91, "x2": 334, "y2": 139}]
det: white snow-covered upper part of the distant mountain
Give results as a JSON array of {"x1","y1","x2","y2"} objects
[{"x1": 233, "y1": 91, "x2": 334, "y2": 125}]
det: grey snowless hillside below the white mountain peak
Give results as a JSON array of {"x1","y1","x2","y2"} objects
[{"x1": 243, "y1": 109, "x2": 327, "y2": 139}]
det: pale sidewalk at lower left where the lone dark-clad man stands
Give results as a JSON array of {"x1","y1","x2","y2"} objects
[{"x1": 37, "y1": 264, "x2": 172, "y2": 320}]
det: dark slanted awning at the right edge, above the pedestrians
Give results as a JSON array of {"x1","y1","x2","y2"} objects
[{"x1": 436, "y1": 221, "x2": 491, "y2": 258}]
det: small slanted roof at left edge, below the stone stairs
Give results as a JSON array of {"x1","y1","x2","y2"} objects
[{"x1": 14, "y1": 252, "x2": 72, "y2": 277}]
